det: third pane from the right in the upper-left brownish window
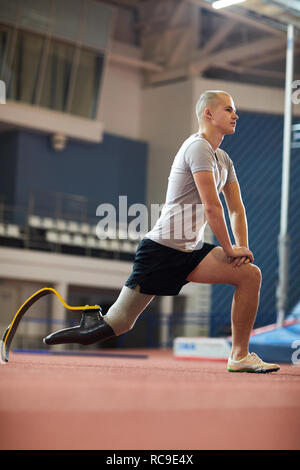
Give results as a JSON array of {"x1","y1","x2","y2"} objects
[{"x1": 7, "y1": 31, "x2": 44, "y2": 104}]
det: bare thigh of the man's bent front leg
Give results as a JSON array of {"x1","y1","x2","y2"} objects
[{"x1": 187, "y1": 246, "x2": 260, "y2": 285}]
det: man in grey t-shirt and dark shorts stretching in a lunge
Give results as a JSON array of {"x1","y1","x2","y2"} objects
[{"x1": 44, "y1": 90, "x2": 280, "y2": 372}]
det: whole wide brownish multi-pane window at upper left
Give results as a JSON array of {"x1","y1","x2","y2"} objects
[{"x1": 0, "y1": 25, "x2": 104, "y2": 119}]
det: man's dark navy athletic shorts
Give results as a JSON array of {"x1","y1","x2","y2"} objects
[{"x1": 125, "y1": 238, "x2": 216, "y2": 295}]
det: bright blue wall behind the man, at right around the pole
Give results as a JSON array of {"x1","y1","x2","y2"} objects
[{"x1": 211, "y1": 112, "x2": 300, "y2": 335}]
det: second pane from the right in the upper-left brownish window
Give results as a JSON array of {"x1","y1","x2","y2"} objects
[{"x1": 39, "y1": 40, "x2": 75, "y2": 111}]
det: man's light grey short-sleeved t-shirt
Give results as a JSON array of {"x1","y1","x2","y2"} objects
[{"x1": 145, "y1": 133, "x2": 237, "y2": 252}]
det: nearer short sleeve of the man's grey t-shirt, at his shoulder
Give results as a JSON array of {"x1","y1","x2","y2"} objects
[{"x1": 185, "y1": 140, "x2": 216, "y2": 173}]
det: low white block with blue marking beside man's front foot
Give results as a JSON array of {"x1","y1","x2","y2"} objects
[{"x1": 173, "y1": 337, "x2": 231, "y2": 361}]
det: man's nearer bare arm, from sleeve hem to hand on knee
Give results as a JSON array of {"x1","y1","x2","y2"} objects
[{"x1": 193, "y1": 171, "x2": 253, "y2": 261}]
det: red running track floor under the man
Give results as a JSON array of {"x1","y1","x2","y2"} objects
[{"x1": 0, "y1": 350, "x2": 300, "y2": 450}]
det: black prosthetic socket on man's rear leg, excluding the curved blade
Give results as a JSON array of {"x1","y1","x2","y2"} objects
[{"x1": 43, "y1": 310, "x2": 116, "y2": 346}]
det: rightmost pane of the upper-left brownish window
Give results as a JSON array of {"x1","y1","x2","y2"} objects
[{"x1": 70, "y1": 50, "x2": 103, "y2": 119}]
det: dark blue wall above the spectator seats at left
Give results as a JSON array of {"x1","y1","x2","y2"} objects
[{"x1": 0, "y1": 131, "x2": 147, "y2": 222}]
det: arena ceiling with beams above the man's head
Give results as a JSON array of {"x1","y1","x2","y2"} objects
[{"x1": 102, "y1": 0, "x2": 300, "y2": 87}]
